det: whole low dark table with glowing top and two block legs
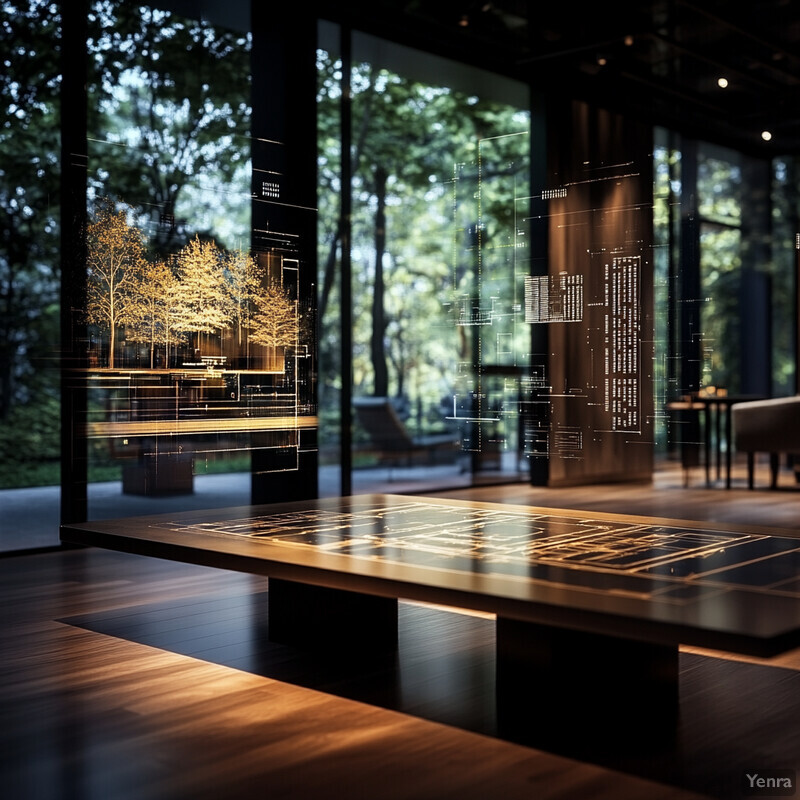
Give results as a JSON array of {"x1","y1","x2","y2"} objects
[{"x1": 61, "y1": 495, "x2": 800, "y2": 752}]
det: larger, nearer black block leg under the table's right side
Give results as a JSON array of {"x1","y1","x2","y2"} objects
[{"x1": 496, "y1": 617, "x2": 678, "y2": 754}]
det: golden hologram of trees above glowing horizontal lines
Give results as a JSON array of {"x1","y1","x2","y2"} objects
[{"x1": 85, "y1": 195, "x2": 316, "y2": 494}]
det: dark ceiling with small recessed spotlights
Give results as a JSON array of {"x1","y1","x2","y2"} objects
[{"x1": 331, "y1": 0, "x2": 800, "y2": 155}]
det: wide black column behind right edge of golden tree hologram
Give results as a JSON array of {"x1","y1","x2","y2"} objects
[{"x1": 251, "y1": 2, "x2": 318, "y2": 503}]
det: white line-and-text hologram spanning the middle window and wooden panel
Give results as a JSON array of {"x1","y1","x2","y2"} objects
[{"x1": 440, "y1": 111, "x2": 653, "y2": 479}]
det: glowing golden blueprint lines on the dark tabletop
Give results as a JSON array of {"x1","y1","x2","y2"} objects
[{"x1": 153, "y1": 499, "x2": 800, "y2": 602}]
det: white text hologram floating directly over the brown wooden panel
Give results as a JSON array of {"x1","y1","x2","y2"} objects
[{"x1": 525, "y1": 148, "x2": 654, "y2": 482}]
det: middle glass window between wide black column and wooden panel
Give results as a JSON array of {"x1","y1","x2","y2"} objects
[{"x1": 318, "y1": 29, "x2": 530, "y2": 493}]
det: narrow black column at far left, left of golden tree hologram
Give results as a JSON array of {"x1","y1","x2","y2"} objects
[{"x1": 60, "y1": 0, "x2": 88, "y2": 522}]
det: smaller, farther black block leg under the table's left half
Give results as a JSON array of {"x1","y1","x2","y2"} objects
[{"x1": 268, "y1": 578, "x2": 397, "y2": 652}]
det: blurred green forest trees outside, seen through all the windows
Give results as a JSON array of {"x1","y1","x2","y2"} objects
[{"x1": 0, "y1": 0, "x2": 797, "y2": 487}]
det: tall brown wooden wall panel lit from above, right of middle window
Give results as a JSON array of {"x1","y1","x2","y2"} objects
[{"x1": 540, "y1": 103, "x2": 653, "y2": 485}]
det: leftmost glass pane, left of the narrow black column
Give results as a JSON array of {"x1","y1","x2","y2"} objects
[{"x1": 0, "y1": 0, "x2": 61, "y2": 550}]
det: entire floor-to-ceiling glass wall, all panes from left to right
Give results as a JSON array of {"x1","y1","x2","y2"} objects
[{"x1": 0, "y1": 0, "x2": 800, "y2": 549}]
